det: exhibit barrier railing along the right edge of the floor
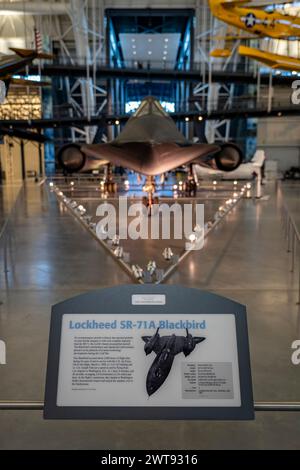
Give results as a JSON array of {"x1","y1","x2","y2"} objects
[{"x1": 282, "y1": 203, "x2": 300, "y2": 304}]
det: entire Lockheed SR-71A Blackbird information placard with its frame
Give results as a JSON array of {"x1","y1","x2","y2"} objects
[{"x1": 45, "y1": 286, "x2": 253, "y2": 419}]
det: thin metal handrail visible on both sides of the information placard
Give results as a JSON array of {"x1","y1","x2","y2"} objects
[{"x1": 0, "y1": 400, "x2": 300, "y2": 412}]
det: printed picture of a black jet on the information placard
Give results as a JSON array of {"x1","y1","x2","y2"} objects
[{"x1": 142, "y1": 328, "x2": 205, "y2": 396}]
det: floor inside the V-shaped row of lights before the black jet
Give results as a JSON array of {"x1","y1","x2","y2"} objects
[{"x1": 52, "y1": 179, "x2": 239, "y2": 271}]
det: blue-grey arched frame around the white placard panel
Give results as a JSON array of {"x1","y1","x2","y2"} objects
[{"x1": 44, "y1": 285, "x2": 254, "y2": 420}]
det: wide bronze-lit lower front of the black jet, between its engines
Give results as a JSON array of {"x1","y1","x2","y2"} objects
[{"x1": 80, "y1": 142, "x2": 220, "y2": 176}]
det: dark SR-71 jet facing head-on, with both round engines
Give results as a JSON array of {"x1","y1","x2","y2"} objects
[{"x1": 58, "y1": 97, "x2": 243, "y2": 177}]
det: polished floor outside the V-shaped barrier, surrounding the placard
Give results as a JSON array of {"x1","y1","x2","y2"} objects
[{"x1": 0, "y1": 179, "x2": 300, "y2": 449}]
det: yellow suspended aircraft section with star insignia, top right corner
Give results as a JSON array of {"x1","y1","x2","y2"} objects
[{"x1": 209, "y1": 0, "x2": 300, "y2": 39}]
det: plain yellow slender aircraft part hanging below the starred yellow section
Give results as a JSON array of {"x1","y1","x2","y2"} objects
[{"x1": 238, "y1": 46, "x2": 300, "y2": 72}]
